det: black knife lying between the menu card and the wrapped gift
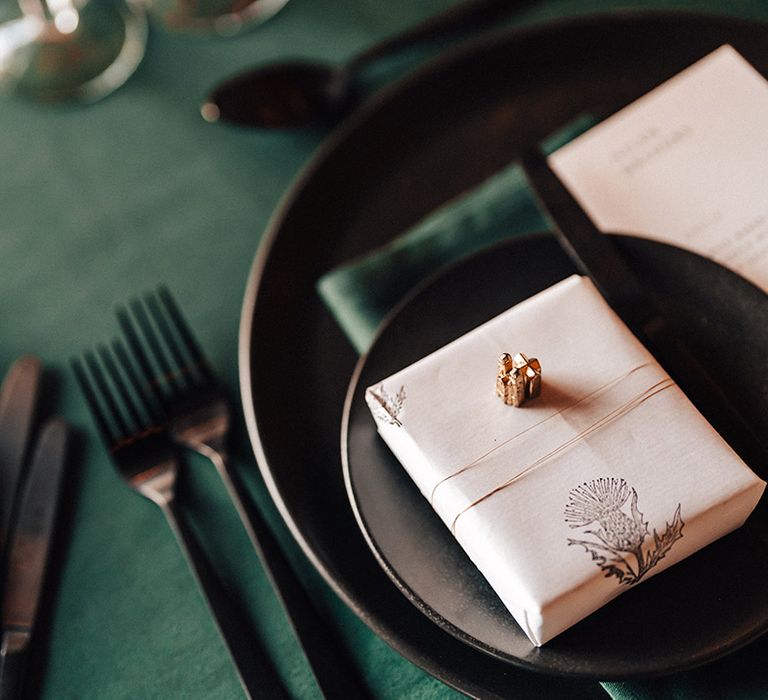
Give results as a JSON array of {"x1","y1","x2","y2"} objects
[{"x1": 522, "y1": 151, "x2": 768, "y2": 470}]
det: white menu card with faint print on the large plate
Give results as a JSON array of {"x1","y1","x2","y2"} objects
[{"x1": 548, "y1": 45, "x2": 768, "y2": 292}]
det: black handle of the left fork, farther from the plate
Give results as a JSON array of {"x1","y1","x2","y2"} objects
[{"x1": 160, "y1": 499, "x2": 288, "y2": 700}]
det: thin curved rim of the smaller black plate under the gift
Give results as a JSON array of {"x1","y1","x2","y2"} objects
[{"x1": 341, "y1": 231, "x2": 768, "y2": 681}]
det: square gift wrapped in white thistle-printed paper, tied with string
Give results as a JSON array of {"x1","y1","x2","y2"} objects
[{"x1": 366, "y1": 276, "x2": 765, "y2": 646}]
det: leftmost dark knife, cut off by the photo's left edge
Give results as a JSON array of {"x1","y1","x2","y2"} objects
[{"x1": 0, "y1": 355, "x2": 42, "y2": 551}]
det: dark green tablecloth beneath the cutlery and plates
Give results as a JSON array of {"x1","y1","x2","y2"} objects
[{"x1": 0, "y1": 0, "x2": 768, "y2": 699}]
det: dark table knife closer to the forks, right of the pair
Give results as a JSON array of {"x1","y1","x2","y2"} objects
[{"x1": 0, "y1": 418, "x2": 69, "y2": 700}]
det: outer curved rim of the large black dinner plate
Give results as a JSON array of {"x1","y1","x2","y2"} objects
[{"x1": 238, "y1": 9, "x2": 755, "y2": 687}]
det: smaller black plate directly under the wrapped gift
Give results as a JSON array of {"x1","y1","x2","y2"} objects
[{"x1": 342, "y1": 235, "x2": 768, "y2": 678}]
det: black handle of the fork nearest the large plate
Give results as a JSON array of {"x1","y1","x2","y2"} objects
[{"x1": 207, "y1": 452, "x2": 369, "y2": 699}]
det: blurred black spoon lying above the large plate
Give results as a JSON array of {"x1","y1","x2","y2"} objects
[{"x1": 201, "y1": 0, "x2": 535, "y2": 129}]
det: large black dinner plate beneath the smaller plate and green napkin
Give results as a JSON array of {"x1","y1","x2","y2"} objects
[{"x1": 240, "y1": 13, "x2": 768, "y2": 697}]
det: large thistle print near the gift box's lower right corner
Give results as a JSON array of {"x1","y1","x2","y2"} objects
[{"x1": 565, "y1": 477, "x2": 685, "y2": 585}]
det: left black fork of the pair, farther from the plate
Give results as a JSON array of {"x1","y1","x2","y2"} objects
[{"x1": 72, "y1": 340, "x2": 285, "y2": 698}]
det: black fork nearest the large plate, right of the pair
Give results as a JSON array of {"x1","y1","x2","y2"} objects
[{"x1": 117, "y1": 287, "x2": 366, "y2": 698}]
